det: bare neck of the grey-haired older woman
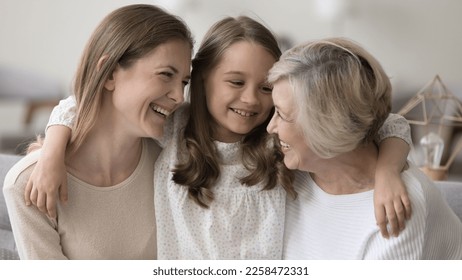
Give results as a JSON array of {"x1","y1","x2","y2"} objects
[{"x1": 311, "y1": 144, "x2": 378, "y2": 195}]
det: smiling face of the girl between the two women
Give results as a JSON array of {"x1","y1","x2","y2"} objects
[{"x1": 205, "y1": 41, "x2": 275, "y2": 143}]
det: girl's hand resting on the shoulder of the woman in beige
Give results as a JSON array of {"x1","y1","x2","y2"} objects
[{"x1": 24, "y1": 155, "x2": 68, "y2": 218}]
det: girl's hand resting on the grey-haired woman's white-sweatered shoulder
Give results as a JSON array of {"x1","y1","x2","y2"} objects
[{"x1": 374, "y1": 168, "x2": 412, "y2": 238}]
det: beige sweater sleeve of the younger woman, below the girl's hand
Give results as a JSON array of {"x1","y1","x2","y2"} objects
[{"x1": 3, "y1": 150, "x2": 67, "y2": 260}]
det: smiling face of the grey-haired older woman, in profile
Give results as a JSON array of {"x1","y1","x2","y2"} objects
[{"x1": 267, "y1": 79, "x2": 318, "y2": 171}]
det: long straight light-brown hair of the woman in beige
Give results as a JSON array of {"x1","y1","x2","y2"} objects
[{"x1": 70, "y1": 4, "x2": 194, "y2": 151}]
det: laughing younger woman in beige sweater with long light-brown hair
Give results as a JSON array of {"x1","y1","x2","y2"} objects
[{"x1": 3, "y1": 5, "x2": 193, "y2": 259}]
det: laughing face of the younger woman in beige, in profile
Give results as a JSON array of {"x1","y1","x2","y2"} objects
[{"x1": 106, "y1": 40, "x2": 191, "y2": 139}]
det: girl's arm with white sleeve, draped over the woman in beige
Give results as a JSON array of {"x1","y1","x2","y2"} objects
[{"x1": 24, "y1": 97, "x2": 75, "y2": 218}]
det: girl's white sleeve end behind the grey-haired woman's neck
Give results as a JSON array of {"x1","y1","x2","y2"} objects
[{"x1": 375, "y1": 114, "x2": 412, "y2": 146}]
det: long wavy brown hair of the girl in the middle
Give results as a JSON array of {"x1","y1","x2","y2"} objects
[{"x1": 173, "y1": 16, "x2": 293, "y2": 208}]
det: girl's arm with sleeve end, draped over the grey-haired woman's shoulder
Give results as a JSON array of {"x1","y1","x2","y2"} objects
[{"x1": 374, "y1": 114, "x2": 412, "y2": 238}]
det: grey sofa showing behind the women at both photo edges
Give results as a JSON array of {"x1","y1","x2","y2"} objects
[{"x1": 0, "y1": 154, "x2": 462, "y2": 260}]
